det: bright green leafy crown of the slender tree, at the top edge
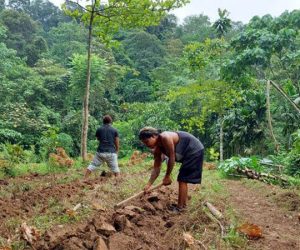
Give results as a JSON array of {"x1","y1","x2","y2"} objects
[{"x1": 62, "y1": 0, "x2": 189, "y2": 43}]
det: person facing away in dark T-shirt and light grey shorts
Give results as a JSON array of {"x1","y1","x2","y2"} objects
[{"x1": 85, "y1": 115, "x2": 120, "y2": 179}]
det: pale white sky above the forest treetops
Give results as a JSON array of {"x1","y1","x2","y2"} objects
[{"x1": 50, "y1": 0, "x2": 300, "y2": 23}]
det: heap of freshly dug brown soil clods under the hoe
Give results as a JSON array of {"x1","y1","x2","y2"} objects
[{"x1": 36, "y1": 187, "x2": 210, "y2": 250}]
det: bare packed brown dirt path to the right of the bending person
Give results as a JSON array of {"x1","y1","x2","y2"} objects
[{"x1": 225, "y1": 180, "x2": 300, "y2": 250}]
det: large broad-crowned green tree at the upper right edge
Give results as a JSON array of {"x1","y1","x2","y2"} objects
[{"x1": 222, "y1": 10, "x2": 300, "y2": 146}]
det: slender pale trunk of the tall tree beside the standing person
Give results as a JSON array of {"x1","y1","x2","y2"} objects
[{"x1": 81, "y1": 9, "x2": 94, "y2": 161}]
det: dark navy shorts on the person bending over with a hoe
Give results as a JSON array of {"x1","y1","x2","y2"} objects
[{"x1": 177, "y1": 150, "x2": 204, "y2": 184}]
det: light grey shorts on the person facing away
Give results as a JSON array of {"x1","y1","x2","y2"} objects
[{"x1": 88, "y1": 152, "x2": 120, "y2": 173}]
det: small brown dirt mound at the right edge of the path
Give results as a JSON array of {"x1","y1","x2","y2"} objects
[{"x1": 274, "y1": 192, "x2": 300, "y2": 212}]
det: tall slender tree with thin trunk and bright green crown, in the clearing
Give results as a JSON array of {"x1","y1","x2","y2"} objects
[{"x1": 63, "y1": 0, "x2": 189, "y2": 160}]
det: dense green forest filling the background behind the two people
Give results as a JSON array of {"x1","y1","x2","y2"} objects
[{"x1": 0, "y1": 0, "x2": 300, "y2": 176}]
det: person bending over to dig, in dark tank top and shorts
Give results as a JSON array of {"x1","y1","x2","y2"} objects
[{"x1": 139, "y1": 127, "x2": 204, "y2": 211}]
